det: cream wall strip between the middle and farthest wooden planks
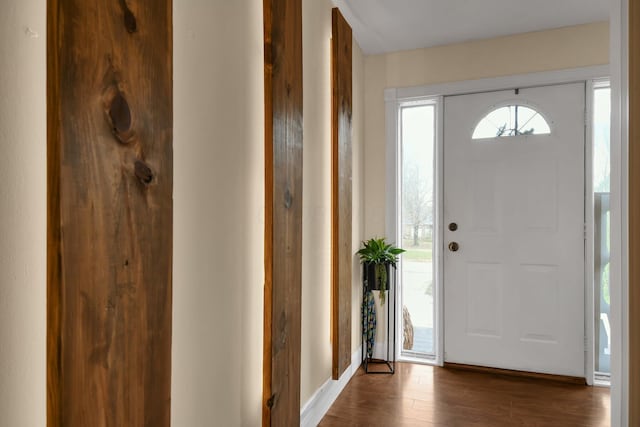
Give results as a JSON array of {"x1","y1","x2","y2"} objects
[{"x1": 300, "y1": 0, "x2": 332, "y2": 405}]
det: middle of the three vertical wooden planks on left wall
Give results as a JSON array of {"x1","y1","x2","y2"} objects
[{"x1": 262, "y1": 0, "x2": 302, "y2": 426}]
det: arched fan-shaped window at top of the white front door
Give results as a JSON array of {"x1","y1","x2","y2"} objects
[{"x1": 472, "y1": 104, "x2": 551, "y2": 139}]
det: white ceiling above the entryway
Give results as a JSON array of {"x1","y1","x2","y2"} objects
[{"x1": 334, "y1": 0, "x2": 609, "y2": 55}]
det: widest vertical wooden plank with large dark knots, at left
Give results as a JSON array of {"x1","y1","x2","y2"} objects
[{"x1": 47, "y1": 0, "x2": 173, "y2": 427}]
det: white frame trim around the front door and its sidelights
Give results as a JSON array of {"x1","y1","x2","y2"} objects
[{"x1": 384, "y1": 65, "x2": 608, "y2": 378}]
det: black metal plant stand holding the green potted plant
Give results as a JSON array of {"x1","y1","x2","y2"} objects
[{"x1": 362, "y1": 265, "x2": 397, "y2": 374}]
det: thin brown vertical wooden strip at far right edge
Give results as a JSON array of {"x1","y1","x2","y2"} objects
[{"x1": 628, "y1": 0, "x2": 640, "y2": 426}]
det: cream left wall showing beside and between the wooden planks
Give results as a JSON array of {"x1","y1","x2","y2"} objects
[{"x1": 0, "y1": 0, "x2": 364, "y2": 427}]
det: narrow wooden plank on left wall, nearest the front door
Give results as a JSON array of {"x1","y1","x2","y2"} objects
[{"x1": 331, "y1": 8, "x2": 353, "y2": 380}]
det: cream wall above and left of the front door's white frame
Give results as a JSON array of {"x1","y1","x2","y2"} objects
[{"x1": 364, "y1": 22, "x2": 609, "y2": 236}]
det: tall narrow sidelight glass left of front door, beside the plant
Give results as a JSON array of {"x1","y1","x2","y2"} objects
[{"x1": 400, "y1": 105, "x2": 435, "y2": 356}]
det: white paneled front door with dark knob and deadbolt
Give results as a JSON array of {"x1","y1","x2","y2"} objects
[{"x1": 444, "y1": 83, "x2": 585, "y2": 377}]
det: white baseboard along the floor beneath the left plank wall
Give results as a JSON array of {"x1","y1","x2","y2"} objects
[{"x1": 300, "y1": 347, "x2": 362, "y2": 427}]
